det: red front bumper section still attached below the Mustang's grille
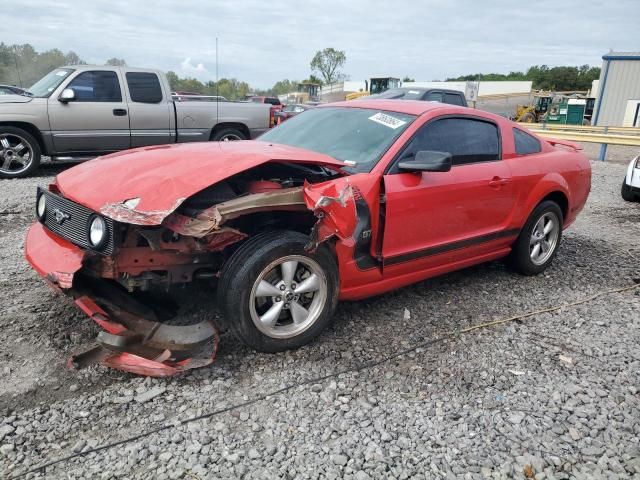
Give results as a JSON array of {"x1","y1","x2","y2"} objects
[{"x1": 25, "y1": 223, "x2": 86, "y2": 289}]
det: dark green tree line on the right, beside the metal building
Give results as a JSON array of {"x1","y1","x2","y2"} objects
[{"x1": 446, "y1": 65, "x2": 600, "y2": 91}]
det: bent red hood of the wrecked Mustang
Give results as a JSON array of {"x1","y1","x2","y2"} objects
[{"x1": 56, "y1": 141, "x2": 344, "y2": 225}]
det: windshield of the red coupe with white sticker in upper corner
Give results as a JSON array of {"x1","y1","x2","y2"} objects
[{"x1": 258, "y1": 107, "x2": 416, "y2": 172}]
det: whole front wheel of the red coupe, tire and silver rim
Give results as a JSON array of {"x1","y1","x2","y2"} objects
[{"x1": 218, "y1": 231, "x2": 339, "y2": 352}]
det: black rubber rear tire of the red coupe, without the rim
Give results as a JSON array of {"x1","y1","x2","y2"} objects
[{"x1": 508, "y1": 200, "x2": 564, "y2": 275}]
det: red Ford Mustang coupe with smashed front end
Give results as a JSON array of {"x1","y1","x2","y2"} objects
[{"x1": 26, "y1": 100, "x2": 591, "y2": 375}]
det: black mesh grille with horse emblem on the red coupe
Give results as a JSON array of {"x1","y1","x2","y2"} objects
[{"x1": 36, "y1": 188, "x2": 114, "y2": 255}]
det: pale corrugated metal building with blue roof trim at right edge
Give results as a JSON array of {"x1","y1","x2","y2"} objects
[{"x1": 593, "y1": 52, "x2": 640, "y2": 127}]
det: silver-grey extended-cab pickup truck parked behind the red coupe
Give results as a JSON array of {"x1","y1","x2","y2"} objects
[{"x1": 0, "y1": 65, "x2": 273, "y2": 178}]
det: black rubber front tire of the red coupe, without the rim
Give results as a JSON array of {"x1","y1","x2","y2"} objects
[{"x1": 218, "y1": 230, "x2": 339, "y2": 353}]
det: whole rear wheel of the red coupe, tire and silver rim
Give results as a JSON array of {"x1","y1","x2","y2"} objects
[{"x1": 509, "y1": 200, "x2": 564, "y2": 275}]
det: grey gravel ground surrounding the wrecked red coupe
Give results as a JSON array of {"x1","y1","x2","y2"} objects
[{"x1": 0, "y1": 147, "x2": 640, "y2": 480}]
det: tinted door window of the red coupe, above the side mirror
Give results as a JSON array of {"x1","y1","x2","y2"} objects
[{"x1": 400, "y1": 118, "x2": 500, "y2": 165}]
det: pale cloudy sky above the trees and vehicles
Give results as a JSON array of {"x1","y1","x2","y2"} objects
[{"x1": 0, "y1": 0, "x2": 640, "y2": 88}]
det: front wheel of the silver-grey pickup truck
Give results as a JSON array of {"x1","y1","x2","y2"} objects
[{"x1": 0, "y1": 127, "x2": 41, "y2": 178}]
